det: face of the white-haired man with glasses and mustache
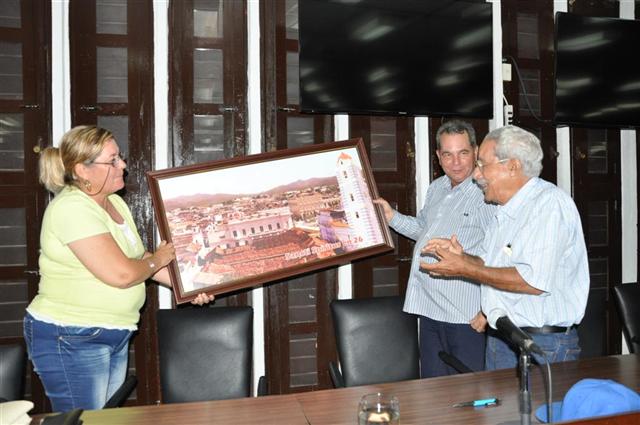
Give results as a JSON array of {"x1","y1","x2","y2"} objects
[{"x1": 473, "y1": 140, "x2": 509, "y2": 205}]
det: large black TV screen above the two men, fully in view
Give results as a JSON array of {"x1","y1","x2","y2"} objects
[{"x1": 298, "y1": 0, "x2": 493, "y2": 118}]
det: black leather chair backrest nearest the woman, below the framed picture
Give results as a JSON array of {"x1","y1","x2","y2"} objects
[{"x1": 157, "y1": 307, "x2": 253, "y2": 403}]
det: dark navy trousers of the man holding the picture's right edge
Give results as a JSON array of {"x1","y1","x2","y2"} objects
[{"x1": 420, "y1": 316, "x2": 486, "y2": 378}]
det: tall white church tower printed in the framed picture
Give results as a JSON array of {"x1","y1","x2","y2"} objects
[{"x1": 336, "y1": 152, "x2": 383, "y2": 250}]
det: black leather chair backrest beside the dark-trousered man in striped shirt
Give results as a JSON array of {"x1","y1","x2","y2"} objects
[{"x1": 331, "y1": 297, "x2": 420, "y2": 387}]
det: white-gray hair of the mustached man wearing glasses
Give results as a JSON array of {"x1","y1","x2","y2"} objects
[{"x1": 484, "y1": 125, "x2": 544, "y2": 177}]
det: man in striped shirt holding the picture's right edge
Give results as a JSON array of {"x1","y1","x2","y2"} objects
[{"x1": 376, "y1": 120, "x2": 495, "y2": 378}]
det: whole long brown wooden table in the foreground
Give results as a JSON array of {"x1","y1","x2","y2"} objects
[{"x1": 32, "y1": 354, "x2": 640, "y2": 425}]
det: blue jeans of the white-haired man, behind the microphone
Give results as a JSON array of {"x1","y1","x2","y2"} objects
[{"x1": 486, "y1": 328, "x2": 580, "y2": 370}]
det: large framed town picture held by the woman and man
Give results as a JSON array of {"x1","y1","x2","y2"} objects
[{"x1": 147, "y1": 139, "x2": 393, "y2": 303}]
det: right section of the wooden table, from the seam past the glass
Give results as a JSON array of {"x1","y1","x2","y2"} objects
[{"x1": 298, "y1": 355, "x2": 640, "y2": 425}]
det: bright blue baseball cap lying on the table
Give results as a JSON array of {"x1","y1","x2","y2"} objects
[{"x1": 536, "y1": 379, "x2": 640, "y2": 423}]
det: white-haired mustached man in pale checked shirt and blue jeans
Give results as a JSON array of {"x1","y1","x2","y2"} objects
[{"x1": 421, "y1": 126, "x2": 589, "y2": 369}]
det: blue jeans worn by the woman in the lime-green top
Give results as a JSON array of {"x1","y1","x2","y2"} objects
[{"x1": 24, "y1": 313, "x2": 132, "y2": 412}]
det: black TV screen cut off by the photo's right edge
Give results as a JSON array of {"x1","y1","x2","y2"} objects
[{"x1": 554, "y1": 12, "x2": 640, "y2": 127}]
